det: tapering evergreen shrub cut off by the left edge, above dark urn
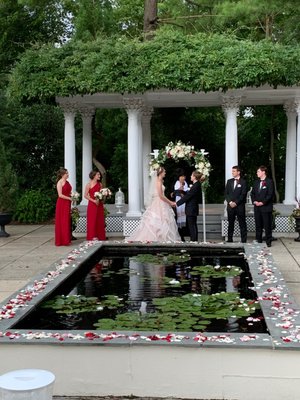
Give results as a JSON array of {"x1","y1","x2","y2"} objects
[{"x1": 0, "y1": 141, "x2": 18, "y2": 212}]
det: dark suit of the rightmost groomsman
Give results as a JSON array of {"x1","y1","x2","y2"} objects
[{"x1": 251, "y1": 178, "x2": 274, "y2": 246}]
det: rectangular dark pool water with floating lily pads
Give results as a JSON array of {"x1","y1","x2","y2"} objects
[{"x1": 14, "y1": 246, "x2": 267, "y2": 333}]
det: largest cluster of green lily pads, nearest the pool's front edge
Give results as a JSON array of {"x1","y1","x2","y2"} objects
[{"x1": 95, "y1": 293, "x2": 258, "y2": 331}]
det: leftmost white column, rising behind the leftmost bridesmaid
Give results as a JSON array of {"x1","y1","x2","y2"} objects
[{"x1": 61, "y1": 104, "x2": 76, "y2": 191}]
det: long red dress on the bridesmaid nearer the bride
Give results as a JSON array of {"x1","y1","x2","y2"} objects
[{"x1": 86, "y1": 182, "x2": 106, "y2": 240}]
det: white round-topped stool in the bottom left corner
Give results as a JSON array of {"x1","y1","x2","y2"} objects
[{"x1": 0, "y1": 369, "x2": 55, "y2": 400}]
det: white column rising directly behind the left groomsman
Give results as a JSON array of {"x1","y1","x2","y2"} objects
[{"x1": 222, "y1": 96, "x2": 241, "y2": 182}]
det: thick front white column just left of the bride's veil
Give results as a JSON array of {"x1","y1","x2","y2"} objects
[{"x1": 124, "y1": 98, "x2": 143, "y2": 217}]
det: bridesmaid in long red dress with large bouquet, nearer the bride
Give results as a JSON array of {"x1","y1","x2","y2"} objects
[{"x1": 84, "y1": 171, "x2": 106, "y2": 240}]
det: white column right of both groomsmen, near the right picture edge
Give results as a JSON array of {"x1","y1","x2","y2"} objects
[{"x1": 283, "y1": 101, "x2": 299, "y2": 204}]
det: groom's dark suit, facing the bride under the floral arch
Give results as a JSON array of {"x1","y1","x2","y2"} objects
[{"x1": 176, "y1": 181, "x2": 201, "y2": 242}]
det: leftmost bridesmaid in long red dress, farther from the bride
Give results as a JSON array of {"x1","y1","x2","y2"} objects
[{"x1": 55, "y1": 168, "x2": 72, "y2": 246}]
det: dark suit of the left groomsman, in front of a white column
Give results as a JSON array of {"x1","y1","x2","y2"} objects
[{"x1": 225, "y1": 178, "x2": 247, "y2": 243}]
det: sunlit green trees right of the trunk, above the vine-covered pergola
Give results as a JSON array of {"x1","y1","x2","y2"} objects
[{"x1": 158, "y1": 0, "x2": 300, "y2": 44}]
